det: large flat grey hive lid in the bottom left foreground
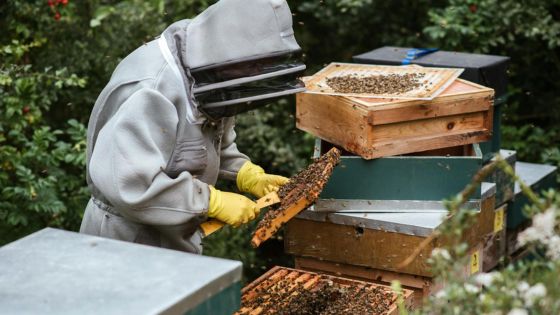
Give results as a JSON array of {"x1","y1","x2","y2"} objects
[{"x1": 0, "y1": 228, "x2": 241, "y2": 314}]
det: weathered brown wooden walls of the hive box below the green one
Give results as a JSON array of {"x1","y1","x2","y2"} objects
[{"x1": 285, "y1": 195, "x2": 495, "y2": 277}]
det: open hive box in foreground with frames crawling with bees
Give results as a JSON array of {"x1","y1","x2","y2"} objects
[{"x1": 236, "y1": 266, "x2": 412, "y2": 315}]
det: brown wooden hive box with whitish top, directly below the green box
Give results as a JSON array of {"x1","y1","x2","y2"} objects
[{"x1": 284, "y1": 183, "x2": 496, "y2": 277}]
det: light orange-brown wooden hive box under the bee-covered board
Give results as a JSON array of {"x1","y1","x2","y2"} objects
[{"x1": 296, "y1": 79, "x2": 494, "y2": 159}]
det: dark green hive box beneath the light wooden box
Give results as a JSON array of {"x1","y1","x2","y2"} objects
[{"x1": 315, "y1": 140, "x2": 482, "y2": 211}]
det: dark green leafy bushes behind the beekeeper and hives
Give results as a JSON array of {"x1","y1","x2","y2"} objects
[{"x1": 0, "y1": 0, "x2": 560, "y2": 278}]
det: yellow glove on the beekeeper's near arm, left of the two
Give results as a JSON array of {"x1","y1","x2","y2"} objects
[{"x1": 208, "y1": 186, "x2": 260, "y2": 227}]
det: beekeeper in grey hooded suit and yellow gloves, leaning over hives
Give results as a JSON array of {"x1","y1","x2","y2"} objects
[{"x1": 80, "y1": 0, "x2": 305, "y2": 253}]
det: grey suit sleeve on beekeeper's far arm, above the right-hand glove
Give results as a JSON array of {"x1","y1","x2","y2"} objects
[{"x1": 220, "y1": 117, "x2": 249, "y2": 180}]
